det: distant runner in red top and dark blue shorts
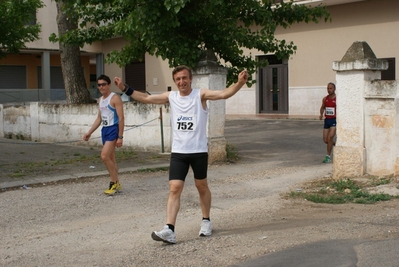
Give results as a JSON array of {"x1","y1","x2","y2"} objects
[{"x1": 319, "y1": 83, "x2": 337, "y2": 163}]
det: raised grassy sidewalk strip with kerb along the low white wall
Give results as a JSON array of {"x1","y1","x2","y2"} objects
[{"x1": 0, "y1": 138, "x2": 169, "y2": 190}]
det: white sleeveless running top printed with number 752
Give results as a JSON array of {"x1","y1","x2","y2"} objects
[{"x1": 169, "y1": 89, "x2": 208, "y2": 154}]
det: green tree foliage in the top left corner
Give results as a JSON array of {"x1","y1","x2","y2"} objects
[{"x1": 0, "y1": 0, "x2": 43, "y2": 58}]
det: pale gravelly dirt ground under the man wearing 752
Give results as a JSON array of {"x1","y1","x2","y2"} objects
[{"x1": 0, "y1": 163, "x2": 399, "y2": 267}]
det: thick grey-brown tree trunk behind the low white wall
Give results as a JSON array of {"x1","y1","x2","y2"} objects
[{"x1": 56, "y1": 0, "x2": 95, "y2": 104}]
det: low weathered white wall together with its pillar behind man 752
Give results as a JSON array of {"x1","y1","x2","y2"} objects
[{"x1": 0, "y1": 58, "x2": 231, "y2": 164}]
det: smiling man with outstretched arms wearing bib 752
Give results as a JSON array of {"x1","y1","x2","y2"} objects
[{"x1": 114, "y1": 66, "x2": 248, "y2": 244}]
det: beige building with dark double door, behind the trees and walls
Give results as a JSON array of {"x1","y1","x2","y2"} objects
[{"x1": 0, "y1": 0, "x2": 399, "y2": 117}]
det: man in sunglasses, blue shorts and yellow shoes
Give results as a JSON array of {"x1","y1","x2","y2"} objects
[{"x1": 83, "y1": 75, "x2": 125, "y2": 195}]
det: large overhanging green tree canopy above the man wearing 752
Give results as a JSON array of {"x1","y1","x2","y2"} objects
[{"x1": 52, "y1": 0, "x2": 329, "y2": 87}]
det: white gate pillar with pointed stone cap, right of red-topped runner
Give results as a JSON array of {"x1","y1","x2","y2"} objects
[{"x1": 333, "y1": 42, "x2": 388, "y2": 179}]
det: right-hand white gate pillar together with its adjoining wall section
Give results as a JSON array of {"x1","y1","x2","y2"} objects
[{"x1": 333, "y1": 42, "x2": 399, "y2": 178}]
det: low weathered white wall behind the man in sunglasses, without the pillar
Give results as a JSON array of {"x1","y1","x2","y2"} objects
[{"x1": 0, "y1": 101, "x2": 171, "y2": 152}]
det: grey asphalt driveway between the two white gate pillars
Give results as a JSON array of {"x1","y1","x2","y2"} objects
[{"x1": 225, "y1": 119, "x2": 326, "y2": 167}]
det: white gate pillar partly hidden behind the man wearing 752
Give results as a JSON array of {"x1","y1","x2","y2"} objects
[{"x1": 192, "y1": 51, "x2": 227, "y2": 164}]
